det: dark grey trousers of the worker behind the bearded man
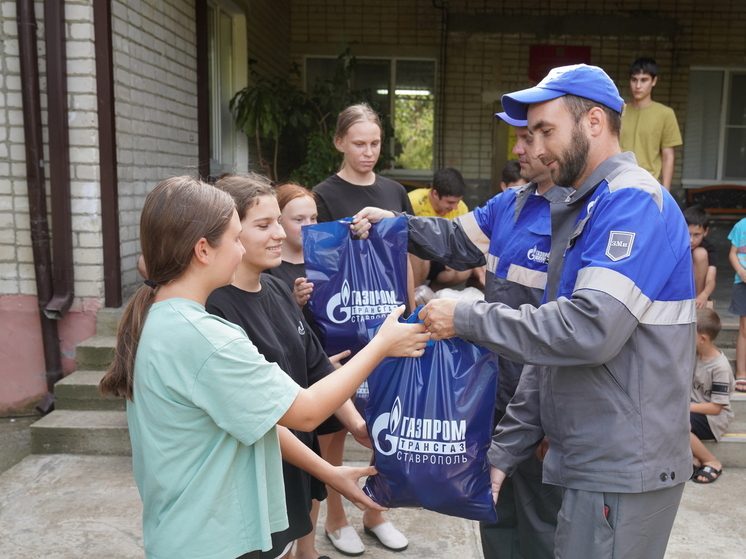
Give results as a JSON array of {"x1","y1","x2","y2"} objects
[{"x1": 479, "y1": 455, "x2": 562, "y2": 559}]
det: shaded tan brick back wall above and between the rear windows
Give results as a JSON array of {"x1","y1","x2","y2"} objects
[{"x1": 291, "y1": 0, "x2": 746, "y2": 202}]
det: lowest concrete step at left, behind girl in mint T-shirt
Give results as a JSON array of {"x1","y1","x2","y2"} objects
[{"x1": 31, "y1": 410, "x2": 132, "y2": 456}]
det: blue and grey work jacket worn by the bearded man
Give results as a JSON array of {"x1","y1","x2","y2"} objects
[{"x1": 454, "y1": 153, "x2": 695, "y2": 493}]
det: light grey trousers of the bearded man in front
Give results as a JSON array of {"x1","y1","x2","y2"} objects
[{"x1": 554, "y1": 483, "x2": 684, "y2": 559}]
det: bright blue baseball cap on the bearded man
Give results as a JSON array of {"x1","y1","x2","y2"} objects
[{"x1": 502, "y1": 64, "x2": 624, "y2": 120}]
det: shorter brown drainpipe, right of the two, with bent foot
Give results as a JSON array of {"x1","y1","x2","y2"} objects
[{"x1": 44, "y1": 1, "x2": 73, "y2": 320}]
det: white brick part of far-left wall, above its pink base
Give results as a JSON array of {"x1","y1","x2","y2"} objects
[{"x1": 0, "y1": 0, "x2": 103, "y2": 302}]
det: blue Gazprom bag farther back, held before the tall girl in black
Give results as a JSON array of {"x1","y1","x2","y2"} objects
[{"x1": 302, "y1": 216, "x2": 407, "y2": 355}]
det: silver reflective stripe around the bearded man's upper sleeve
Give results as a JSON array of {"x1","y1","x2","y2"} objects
[{"x1": 573, "y1": 267, "x2": 696, "y2": 325}]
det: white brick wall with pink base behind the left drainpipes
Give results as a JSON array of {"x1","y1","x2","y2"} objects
[{"x1": 0, "y1": 0, "x2": 103, "y2": 414}]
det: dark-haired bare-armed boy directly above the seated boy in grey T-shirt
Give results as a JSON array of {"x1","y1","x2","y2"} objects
[{"x1": 684, "y1": 205, "x2": 717, "y2": 309}]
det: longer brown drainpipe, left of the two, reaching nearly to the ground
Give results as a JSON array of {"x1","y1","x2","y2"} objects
[{"x1": 16, "y1": 0, "x2": 62, "y2": 413}]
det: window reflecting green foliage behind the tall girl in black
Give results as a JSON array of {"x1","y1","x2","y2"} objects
[{"x1": 306, "y1": 57, "x2": 435, "y2": 174}]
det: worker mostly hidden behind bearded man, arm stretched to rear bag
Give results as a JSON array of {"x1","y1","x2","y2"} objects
[{"x1": 356, "y1": 113, "x2": 571, "y2": 559}]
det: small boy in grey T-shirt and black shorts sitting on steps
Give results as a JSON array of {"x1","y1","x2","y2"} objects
[{"x1": 689, "y1": 309, "x2": 734, "y2": 483}]
